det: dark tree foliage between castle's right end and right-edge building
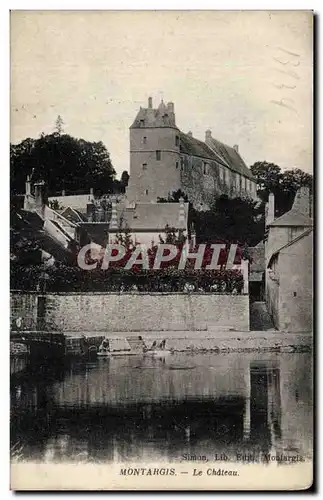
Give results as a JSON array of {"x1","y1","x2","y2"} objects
[{"x1": 250, "y1": 161, "x2": 313, "y2": 216}]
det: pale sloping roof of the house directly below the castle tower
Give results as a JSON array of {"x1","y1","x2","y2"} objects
[{"x1": 117, "y1": 203, "x2": 188, "y2": 231}]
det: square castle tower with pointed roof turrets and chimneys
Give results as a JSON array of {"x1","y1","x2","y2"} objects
[{"x1": 126, "y1": 97, "x2": 181, "y2": 203}]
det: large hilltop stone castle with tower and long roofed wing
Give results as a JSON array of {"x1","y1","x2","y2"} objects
[{"x1": 126, "y1": 97, "x2": 257, "y2": 210}]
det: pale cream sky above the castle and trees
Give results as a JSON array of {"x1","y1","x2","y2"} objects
[{"x1": 10, "y1": 10, "x2": 313, "y2": 176}]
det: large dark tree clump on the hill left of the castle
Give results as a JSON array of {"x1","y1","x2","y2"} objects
[{"x1": 10, "y1": 132, "x2": 115, "y2": 194}]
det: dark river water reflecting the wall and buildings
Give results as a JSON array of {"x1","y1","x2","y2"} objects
[{"x1": 11, "y1": 353, "x2": 313, "y2": 463}]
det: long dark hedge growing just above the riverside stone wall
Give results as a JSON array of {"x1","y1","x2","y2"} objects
[{"x1": 10, "y1": 265, "x2": 243, "y2": 294}]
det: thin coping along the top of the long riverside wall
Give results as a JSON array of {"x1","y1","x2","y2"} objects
[{"x1": 10, "y1": 290, "x2": 249, "y2": 297}]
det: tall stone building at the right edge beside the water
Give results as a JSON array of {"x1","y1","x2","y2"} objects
[{"x1": 265, "y1": 188, "x2": 313, "y2": 332}]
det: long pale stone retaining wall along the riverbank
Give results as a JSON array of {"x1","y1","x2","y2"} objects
[{"x1": 12, "y1": 292, "x2": 249, "y2": 333}]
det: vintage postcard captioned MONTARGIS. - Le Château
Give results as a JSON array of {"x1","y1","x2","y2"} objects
[{"x1": 10, "y1": 10, "x2": 314, "y2": 491}]
